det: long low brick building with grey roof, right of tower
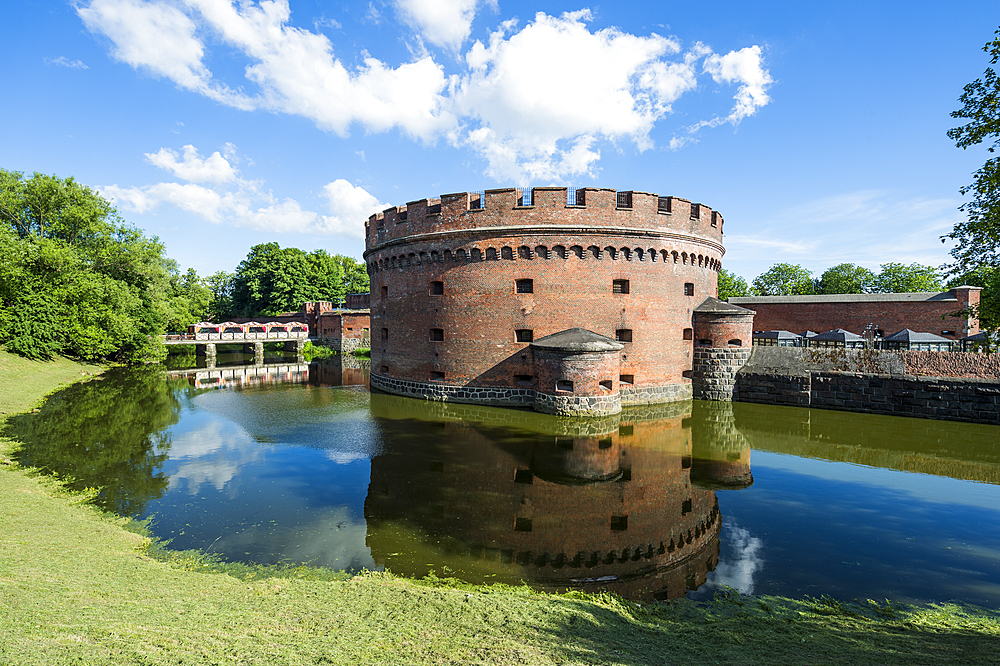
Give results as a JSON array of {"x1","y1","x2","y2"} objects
[{"x1": 729, "y1": 286, "x2": 982, "y2": 340}]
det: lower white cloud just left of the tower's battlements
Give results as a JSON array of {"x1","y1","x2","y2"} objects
[{"x1": 100, "y1": 144, "x2": 388, "y2": 238}]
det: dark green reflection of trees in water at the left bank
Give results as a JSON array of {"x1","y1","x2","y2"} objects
[{"x1": 4, "y1": 368, "x2": 186, "y2": 517}]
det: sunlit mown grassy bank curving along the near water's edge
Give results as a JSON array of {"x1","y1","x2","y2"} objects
[{"x1": 0, "y1": 352, "x2": 1000, "y2": 665}]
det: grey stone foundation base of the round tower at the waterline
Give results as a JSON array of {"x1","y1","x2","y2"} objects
[{"x1": 371, "y1": 372, "x2": 691, "y2": 416}]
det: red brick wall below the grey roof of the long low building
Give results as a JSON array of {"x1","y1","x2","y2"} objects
[{"x1": 738, "y1": 290, "x2": 979, "y2": 340}]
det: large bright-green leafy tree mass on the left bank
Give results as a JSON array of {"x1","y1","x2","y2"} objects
[{"x1": 0, "y1": 169, "x2": 168, "y2": 362}]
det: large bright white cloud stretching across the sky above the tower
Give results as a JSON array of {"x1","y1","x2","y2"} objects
[{"x1": 77, "y1": 0, "x2": 772, "y2": 182}]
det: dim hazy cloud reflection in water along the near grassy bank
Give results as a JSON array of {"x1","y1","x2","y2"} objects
[{"x1": 212, "y1": 506, "x2": 376, "y2": 569}]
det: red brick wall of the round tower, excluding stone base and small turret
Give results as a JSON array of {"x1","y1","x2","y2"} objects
[{"x1": 365, "y1": 188, "x2": 723, "y2": 386}]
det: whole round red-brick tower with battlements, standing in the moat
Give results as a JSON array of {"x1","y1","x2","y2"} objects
[{"x1": 365, "y1": 188, "x2": 728, "y2": 415}]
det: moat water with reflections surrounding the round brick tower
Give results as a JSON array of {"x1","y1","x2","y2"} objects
[{"x1": 6, "y1": 354, "x2": 1000, "y2": 608}]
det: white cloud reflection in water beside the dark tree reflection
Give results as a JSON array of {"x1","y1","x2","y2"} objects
[{"x1": 170, "y1": 419, "x2": 261, "y2": 495}]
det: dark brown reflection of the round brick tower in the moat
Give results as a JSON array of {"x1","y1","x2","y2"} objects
[{"x1": 365, "y1": 394, "x2": 752, "y2": 601}]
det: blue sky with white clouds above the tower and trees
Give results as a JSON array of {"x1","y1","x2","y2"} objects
[{"x1": 0, "y1": 0, "x2": 1000, "y2": 279}]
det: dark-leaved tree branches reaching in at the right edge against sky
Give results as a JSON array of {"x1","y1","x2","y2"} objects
[{"x1": 941, "y1": 29, "x2": 1000, "y2": 274}]
